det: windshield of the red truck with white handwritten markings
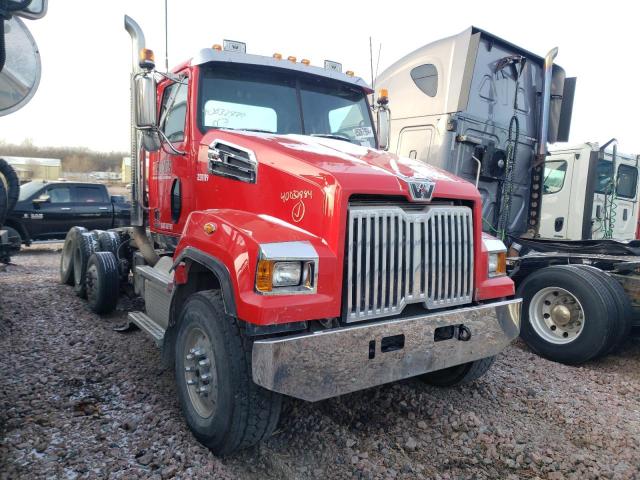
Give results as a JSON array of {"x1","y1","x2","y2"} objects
[{"x1": 198, "y1": 63, "x2": 376, "y2": 148}]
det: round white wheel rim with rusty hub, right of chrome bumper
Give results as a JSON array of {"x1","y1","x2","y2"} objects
[{"x1": 529, "y1": 287, "x2": 585, "y2": 345}]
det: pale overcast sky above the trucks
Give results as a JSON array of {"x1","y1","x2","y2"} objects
[{"x1": 0, "y1": 0, "x2": 640, "y2": 153}]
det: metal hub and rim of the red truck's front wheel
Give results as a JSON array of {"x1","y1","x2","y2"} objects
[{"x1": 184, "y1": 327, "x2": 218, "y2": 418}]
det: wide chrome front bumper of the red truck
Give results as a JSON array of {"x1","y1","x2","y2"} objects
[{"x1": 252, "y1": 299, "x2": 521, "y2": 402}]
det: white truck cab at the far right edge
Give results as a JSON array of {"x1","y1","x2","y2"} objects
[{"x1": 539, "y1": 142, "x2": 640, "y2": 240}]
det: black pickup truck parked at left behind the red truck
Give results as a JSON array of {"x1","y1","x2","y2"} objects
[{"x1": 3, "y1": 181, "x2": 131, "y2": 249}]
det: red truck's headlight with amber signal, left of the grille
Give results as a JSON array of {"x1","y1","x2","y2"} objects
[{"x1": 256, "y1": 242, "x2": 318, "y2": 295}]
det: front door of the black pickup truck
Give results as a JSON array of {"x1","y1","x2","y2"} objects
[{"x1": 28, "y1": 184, "x2": 74, "y2": 240}]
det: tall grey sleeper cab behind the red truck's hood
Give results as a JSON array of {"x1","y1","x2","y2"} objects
[{"x1": 376, "y1": 27, "x2": 575, "y2": 238}]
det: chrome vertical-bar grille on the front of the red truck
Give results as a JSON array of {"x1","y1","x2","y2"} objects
[{"x1": 345, "y1": 206, "x2": 474, "y2": 322}]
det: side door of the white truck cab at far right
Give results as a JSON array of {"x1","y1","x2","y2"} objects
[{"x1": 539, "y1": 158, "x2": 582, "y2": 239}]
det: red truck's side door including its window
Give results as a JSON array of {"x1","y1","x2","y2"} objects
[{"x1": 150, "y1": 75, "x2": 192, "y2": 240}]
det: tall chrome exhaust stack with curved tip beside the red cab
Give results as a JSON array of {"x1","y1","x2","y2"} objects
[{"x1": 124, "y1": 15, "x2": 159, "y2": 266}]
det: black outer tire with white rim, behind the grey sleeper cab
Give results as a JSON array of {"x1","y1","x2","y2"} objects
[{"x1": 516, "y1": 265, "x2": 618, "y2": 365}]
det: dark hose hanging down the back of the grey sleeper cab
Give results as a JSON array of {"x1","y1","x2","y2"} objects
[{"x1": 496, "y1": 55, "x2": 527, "y2": 241}]
